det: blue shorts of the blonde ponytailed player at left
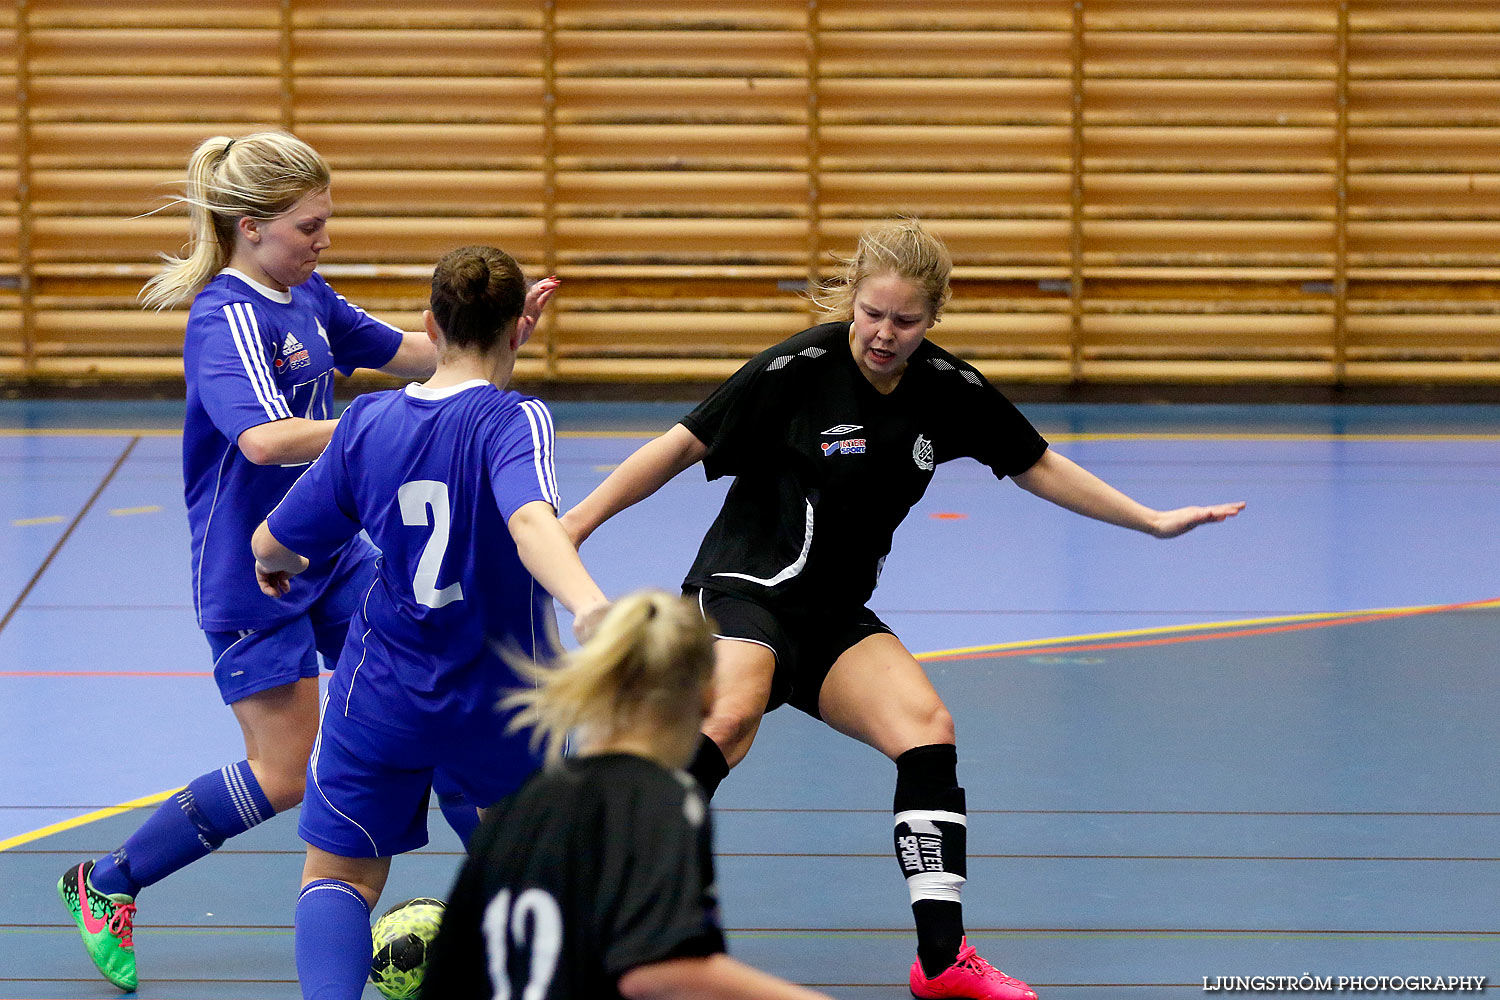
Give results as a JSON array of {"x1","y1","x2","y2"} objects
[{"x1": 204, "y1": 546, "x2": 375, "y2": 705}]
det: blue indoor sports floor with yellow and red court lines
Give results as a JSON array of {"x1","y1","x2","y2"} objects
[{"x1": 0, "y1": 402, "x2": 1500, "y2": 1000}]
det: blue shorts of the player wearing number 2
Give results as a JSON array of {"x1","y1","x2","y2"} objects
[{"x1": 297, "y1": 702, "x2": 542, "y2": 858}]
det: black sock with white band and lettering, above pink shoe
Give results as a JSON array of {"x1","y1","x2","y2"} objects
[{"x1": 893, "y1": 744, "x2": 968, "y2": 979}]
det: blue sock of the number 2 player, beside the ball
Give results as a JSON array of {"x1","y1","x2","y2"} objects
[{"x1": 296, "y1": 879, "x2": 375, "y2": 1000}]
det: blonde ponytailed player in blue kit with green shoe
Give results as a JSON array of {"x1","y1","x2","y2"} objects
[{"x1": 59, "y1": 132, "x2": 540, "y2": 990}]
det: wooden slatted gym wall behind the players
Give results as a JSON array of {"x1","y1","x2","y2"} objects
[{"x1": 0, "y1": 0, "x2": 1500, "y2": 384}]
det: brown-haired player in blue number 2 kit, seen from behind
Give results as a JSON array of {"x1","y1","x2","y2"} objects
[{"x1": 252, "y1": 247, "x2": 608, "y2": 1000}]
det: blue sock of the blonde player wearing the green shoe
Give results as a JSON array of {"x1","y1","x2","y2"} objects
[{"x1": 89, "y1": 760, "x2": 276, "y2": 897}]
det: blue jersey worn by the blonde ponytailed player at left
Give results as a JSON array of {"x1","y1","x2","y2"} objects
[{"x1": 183, "y1": 270, "x2": 402, "y2": 631}]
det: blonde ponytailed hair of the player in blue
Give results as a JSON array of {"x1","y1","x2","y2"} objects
[{"x1": 140, "y1": 132, "x2": 332, "y2": 309}]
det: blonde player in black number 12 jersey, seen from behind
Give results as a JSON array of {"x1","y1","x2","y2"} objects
[{"x1": 422, "y1": 591, "x2": 827, "y2": 1000}]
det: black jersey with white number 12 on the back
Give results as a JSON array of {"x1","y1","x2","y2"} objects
[{"x1": 423, "y1": 754, "x2": 725, "y2": 1000}]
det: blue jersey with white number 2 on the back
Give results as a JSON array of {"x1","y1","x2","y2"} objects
[{"x1": 269, "y1": 381, "x2": 558, "y2": 733}]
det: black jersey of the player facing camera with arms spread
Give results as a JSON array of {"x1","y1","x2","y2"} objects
[{"x1": 683, "y1": 322, "x2": 1047, "y2": 609}]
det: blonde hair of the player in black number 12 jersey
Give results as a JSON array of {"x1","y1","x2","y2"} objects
[{"x1": 501, "y1": 591, "x2": 714, "y2": 762}]
